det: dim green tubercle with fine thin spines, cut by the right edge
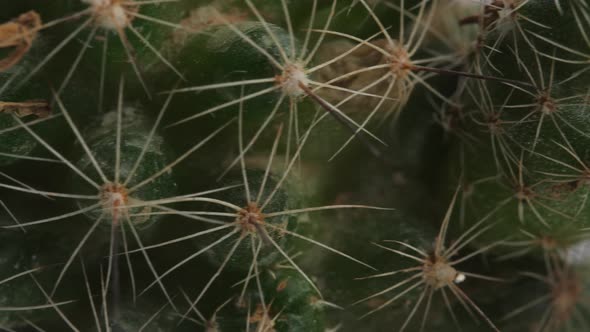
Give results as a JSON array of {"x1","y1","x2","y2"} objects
[{"x1": 457, "y1": 167, "x2": 587, "y2": 252}]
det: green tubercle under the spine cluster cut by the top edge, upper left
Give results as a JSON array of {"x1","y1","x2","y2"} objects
[{"x1": 15, "y1": 0, "x2": 185, "y2": 98}]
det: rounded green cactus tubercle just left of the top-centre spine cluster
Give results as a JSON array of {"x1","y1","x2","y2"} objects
[{"x1": 162, "y1": 22, "x2": 298, "y2": 130}]
